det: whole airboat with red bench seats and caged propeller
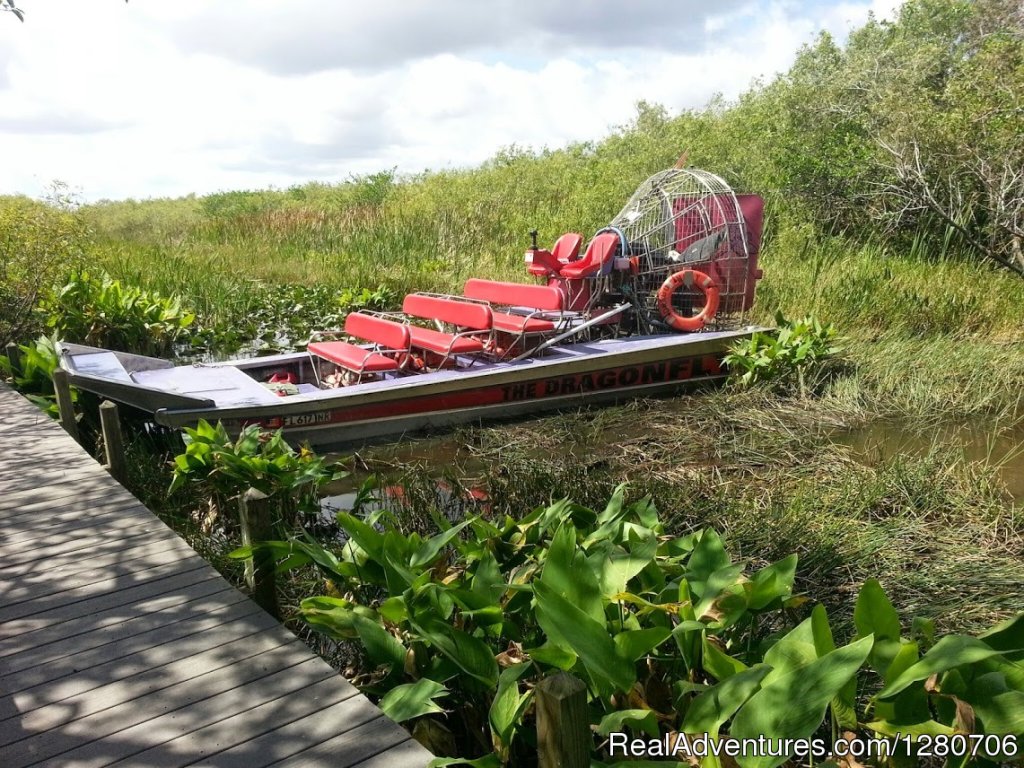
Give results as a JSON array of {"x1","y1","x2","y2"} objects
[{"x1": 59, "y1": 168, "x2": 764, "y2": 449}]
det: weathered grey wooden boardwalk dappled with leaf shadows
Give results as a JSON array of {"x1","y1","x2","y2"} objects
[{"x1": 0, "y1": 384, "x2": 431, "y2": 768}]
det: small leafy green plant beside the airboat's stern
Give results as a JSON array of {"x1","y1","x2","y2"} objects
[{"x1": 724, "y1": 313, "x2": 842, "y2": 394}]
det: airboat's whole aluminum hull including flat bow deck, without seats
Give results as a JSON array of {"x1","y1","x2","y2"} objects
[{"x1": 61, "y1": 328, "x2": 759, "y2": 449}]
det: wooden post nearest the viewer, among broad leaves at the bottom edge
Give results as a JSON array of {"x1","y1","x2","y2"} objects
[{"x1": 537, "y1": 672, "x2": 593, "y2": 768}]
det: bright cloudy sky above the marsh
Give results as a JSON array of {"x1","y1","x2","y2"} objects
[{"x1": 0, "y1": 0, "x2": 900, "y2": 202}]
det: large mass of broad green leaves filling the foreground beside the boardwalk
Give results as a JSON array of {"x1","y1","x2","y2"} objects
[{"x1": 232, "y1": 486, "x2": 1024, "y2": 768}]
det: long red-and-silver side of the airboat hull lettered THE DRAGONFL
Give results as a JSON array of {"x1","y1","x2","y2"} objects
[{"x1": 59, "y1": 329, "x2": 757, "y2": 450}]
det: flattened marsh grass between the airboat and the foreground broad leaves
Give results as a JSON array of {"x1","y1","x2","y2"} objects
[{"x1": 333, "y1": 390, "x2": 1024, "y2": 631}]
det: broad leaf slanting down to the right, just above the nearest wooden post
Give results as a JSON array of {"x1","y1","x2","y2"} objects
[{"x1": 534, "y1": 582, "x2": 636, "y2": 694}]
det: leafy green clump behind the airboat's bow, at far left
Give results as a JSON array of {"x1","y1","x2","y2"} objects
[{"x1": 42, "y1": 271, "x2": 196, "y2": 355}]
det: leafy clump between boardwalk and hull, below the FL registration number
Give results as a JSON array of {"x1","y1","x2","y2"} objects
[{"x1": 168, "y1": 420, "x2": 345, "y2": 527}]
